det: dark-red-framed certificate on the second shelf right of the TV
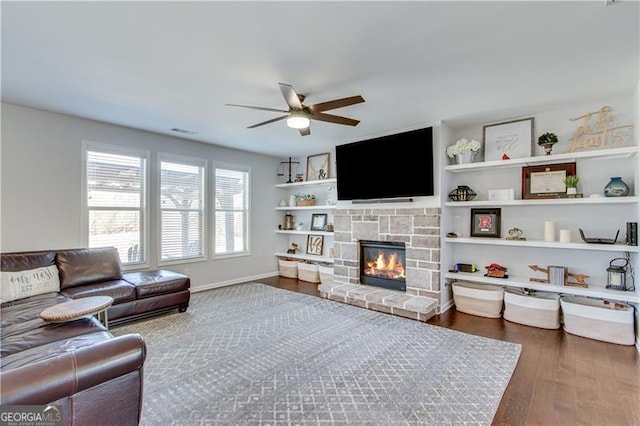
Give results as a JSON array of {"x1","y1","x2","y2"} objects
[{"x1": 522, "y1": 162, "x2": 576, "y2": 200}]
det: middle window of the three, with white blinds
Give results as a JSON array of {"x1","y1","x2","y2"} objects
[{"x1": 160, "y1": 155, "x2": 206, "y2": 261}]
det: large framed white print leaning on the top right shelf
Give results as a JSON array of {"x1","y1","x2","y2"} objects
[{"x1": 483, "y1": 117, "x2": 534, "y2": 161}]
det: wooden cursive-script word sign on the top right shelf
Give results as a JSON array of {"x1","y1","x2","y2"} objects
[{"x1": 569, "y1": 106, "x2": 633, "y2": 152}]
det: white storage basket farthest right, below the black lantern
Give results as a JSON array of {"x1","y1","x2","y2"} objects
[{"x1": 560, "y1": 296, "x2": 635, "y2": 345}]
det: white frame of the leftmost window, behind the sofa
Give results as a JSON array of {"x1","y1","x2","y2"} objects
[{"x1": 80, "y1": 140, "x2": 151, "y2": 270}]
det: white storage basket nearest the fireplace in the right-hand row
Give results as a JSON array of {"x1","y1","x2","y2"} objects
[{"x1": 451, "y1": 281, "x2": 504, "y2": 318}]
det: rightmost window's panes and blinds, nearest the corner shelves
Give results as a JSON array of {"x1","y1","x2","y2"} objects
[{"x1": 214, "y1": 165, "x2": 249, "y2": 255}]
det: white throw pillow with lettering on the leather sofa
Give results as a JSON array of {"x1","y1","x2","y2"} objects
[{"x1": 0, "y1": 265, "x2": 60, "y2": 303}]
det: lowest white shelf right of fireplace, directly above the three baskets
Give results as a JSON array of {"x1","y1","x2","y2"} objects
[{"x1": 445, "y1": 271, "x2": 640, "y2": 303}]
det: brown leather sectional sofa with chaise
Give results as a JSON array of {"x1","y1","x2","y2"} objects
[{"x1": 0, "y1": 248, "x2": 190, "y2": 425}]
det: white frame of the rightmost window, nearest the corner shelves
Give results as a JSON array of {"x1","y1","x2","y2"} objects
[{"x1": 211, "y1": 161, "x2": 252, "y2": 260}]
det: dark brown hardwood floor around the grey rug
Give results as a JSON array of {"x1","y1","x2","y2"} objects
[{"x1": 260, "y1": 277, "x2": 640, "y2": 426}]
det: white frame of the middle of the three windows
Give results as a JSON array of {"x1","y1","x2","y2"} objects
[{"x1": 156, "y1": 152, "x2": 209, "y2": 266}]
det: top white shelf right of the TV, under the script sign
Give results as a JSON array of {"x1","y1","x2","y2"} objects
[{"x1": 445, "y1": 146, "x2": 640, "y2": 173}]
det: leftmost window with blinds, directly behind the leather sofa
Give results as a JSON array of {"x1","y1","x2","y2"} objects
[{"x1": 84, "y1": 144, "x2": 149, "y2": 265}]
